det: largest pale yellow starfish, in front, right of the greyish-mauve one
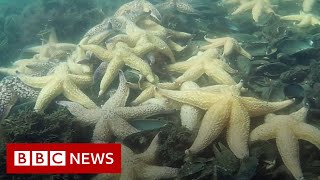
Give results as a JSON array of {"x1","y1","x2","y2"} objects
[{"x1": 158, "y1": 82, "x2": 293, "y2": 159}]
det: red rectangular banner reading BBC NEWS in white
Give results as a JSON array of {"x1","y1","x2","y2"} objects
[{"x1": 7, "y1": 143, "x2": 121, "y2": 174}]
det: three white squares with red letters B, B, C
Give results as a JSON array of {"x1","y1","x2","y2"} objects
[{"x1": 14, "y1": 151, "x2": 66, "y2": 166}]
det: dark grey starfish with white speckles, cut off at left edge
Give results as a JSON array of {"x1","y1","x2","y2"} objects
[{"x1": 0, "y1": 76, "x2": 39, "y2": 120}]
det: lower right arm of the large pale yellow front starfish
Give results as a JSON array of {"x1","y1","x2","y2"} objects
[{"x1": 227, "y1": 99, "x2": 250, "y2": 159}]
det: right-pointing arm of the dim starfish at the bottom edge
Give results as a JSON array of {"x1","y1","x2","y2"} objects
[{"x1": 139, "y1": 165, "x2": 179, "y2": 179}]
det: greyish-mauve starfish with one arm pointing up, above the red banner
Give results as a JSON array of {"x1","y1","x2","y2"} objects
[{"x1": 58, "y1": 71, "x2": 172, "y2": 142}]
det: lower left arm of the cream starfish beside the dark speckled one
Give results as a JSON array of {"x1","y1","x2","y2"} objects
[{"x1": 34, "y1": 80, "x2": 63, "y2": 112}]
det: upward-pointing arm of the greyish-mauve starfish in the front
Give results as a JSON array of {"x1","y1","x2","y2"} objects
[{"x1": 102, "y1": 71, "x2": 130, "y2": 109}]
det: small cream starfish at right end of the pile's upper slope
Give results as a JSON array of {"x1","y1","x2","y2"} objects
[{"x1": 200, "y1": 36, "x2": 252, "y2": 59}]
